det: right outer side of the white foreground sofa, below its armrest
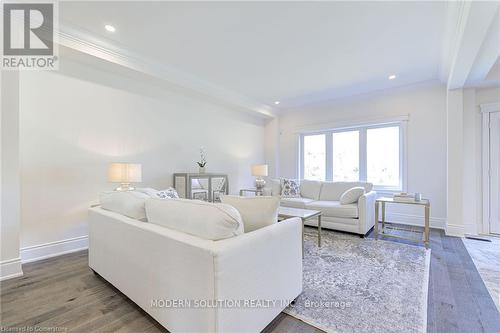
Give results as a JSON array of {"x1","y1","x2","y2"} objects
[{"x1": 214, "y1": 218, "x2": 302, "y2": 332}]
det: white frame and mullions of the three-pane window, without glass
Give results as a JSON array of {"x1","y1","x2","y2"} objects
[{"x1": 298, "y1": 120, "x2": 408, "y2": 194}]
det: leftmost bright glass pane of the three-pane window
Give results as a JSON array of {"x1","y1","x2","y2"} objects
[{"x1": 303, "y1": 134, "x2": 326, "y2": 180}]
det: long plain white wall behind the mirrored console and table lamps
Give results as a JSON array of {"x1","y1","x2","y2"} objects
[{"x1": 16, "y1": 58, "x2": 264, "y2": 260}]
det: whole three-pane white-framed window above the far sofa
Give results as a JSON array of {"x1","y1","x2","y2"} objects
[{"x1": 300, "y1": 122, "x2": 406, "y2": 191}]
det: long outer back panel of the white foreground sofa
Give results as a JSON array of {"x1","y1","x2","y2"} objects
[{"x1": 88, "y1": 207, "x2": 216, "y2": 332}]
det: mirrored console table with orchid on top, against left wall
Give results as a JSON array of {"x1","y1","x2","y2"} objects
[{"x1": 174, "y1": 173, "x2": 229, "y2": 202}]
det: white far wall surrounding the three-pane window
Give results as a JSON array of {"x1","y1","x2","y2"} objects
[{"x1": 267, "y1": 82, "x2": 446, "y2": 228}]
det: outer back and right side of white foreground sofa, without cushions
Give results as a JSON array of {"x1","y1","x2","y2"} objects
[{"x1": 89, "y1": 199, "x2": 302, "y2": 332}]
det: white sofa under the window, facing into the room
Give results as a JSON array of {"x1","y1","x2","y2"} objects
[{"x1": 268, "y1": 179, "x2": 377, "y2": 237}]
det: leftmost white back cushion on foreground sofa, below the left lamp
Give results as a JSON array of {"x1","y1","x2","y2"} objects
[{"x1": 99, "y1": 191, "x2": 150, "y2": 221}]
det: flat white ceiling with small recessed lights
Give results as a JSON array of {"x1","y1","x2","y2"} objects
[{"x1": 59, "y1": 2, "x2": 446, "y2": 109}]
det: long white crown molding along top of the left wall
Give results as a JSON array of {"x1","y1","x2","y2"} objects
[{"x1": 57, "y1": 25, "x2": 276, "y2": 119}]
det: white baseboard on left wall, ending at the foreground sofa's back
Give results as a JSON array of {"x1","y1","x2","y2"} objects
[{"x1": 21, "y1": 236, "x2": 89, "y2": 263}]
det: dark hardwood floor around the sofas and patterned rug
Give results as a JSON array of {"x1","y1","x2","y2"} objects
[{"x1": 0, "y1": 226, "x2": 500, "y2": 333}]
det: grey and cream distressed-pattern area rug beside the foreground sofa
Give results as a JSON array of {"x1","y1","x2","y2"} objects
[{"x1": 285, "y1": 228, "x2": 430, "y2": 333}]
